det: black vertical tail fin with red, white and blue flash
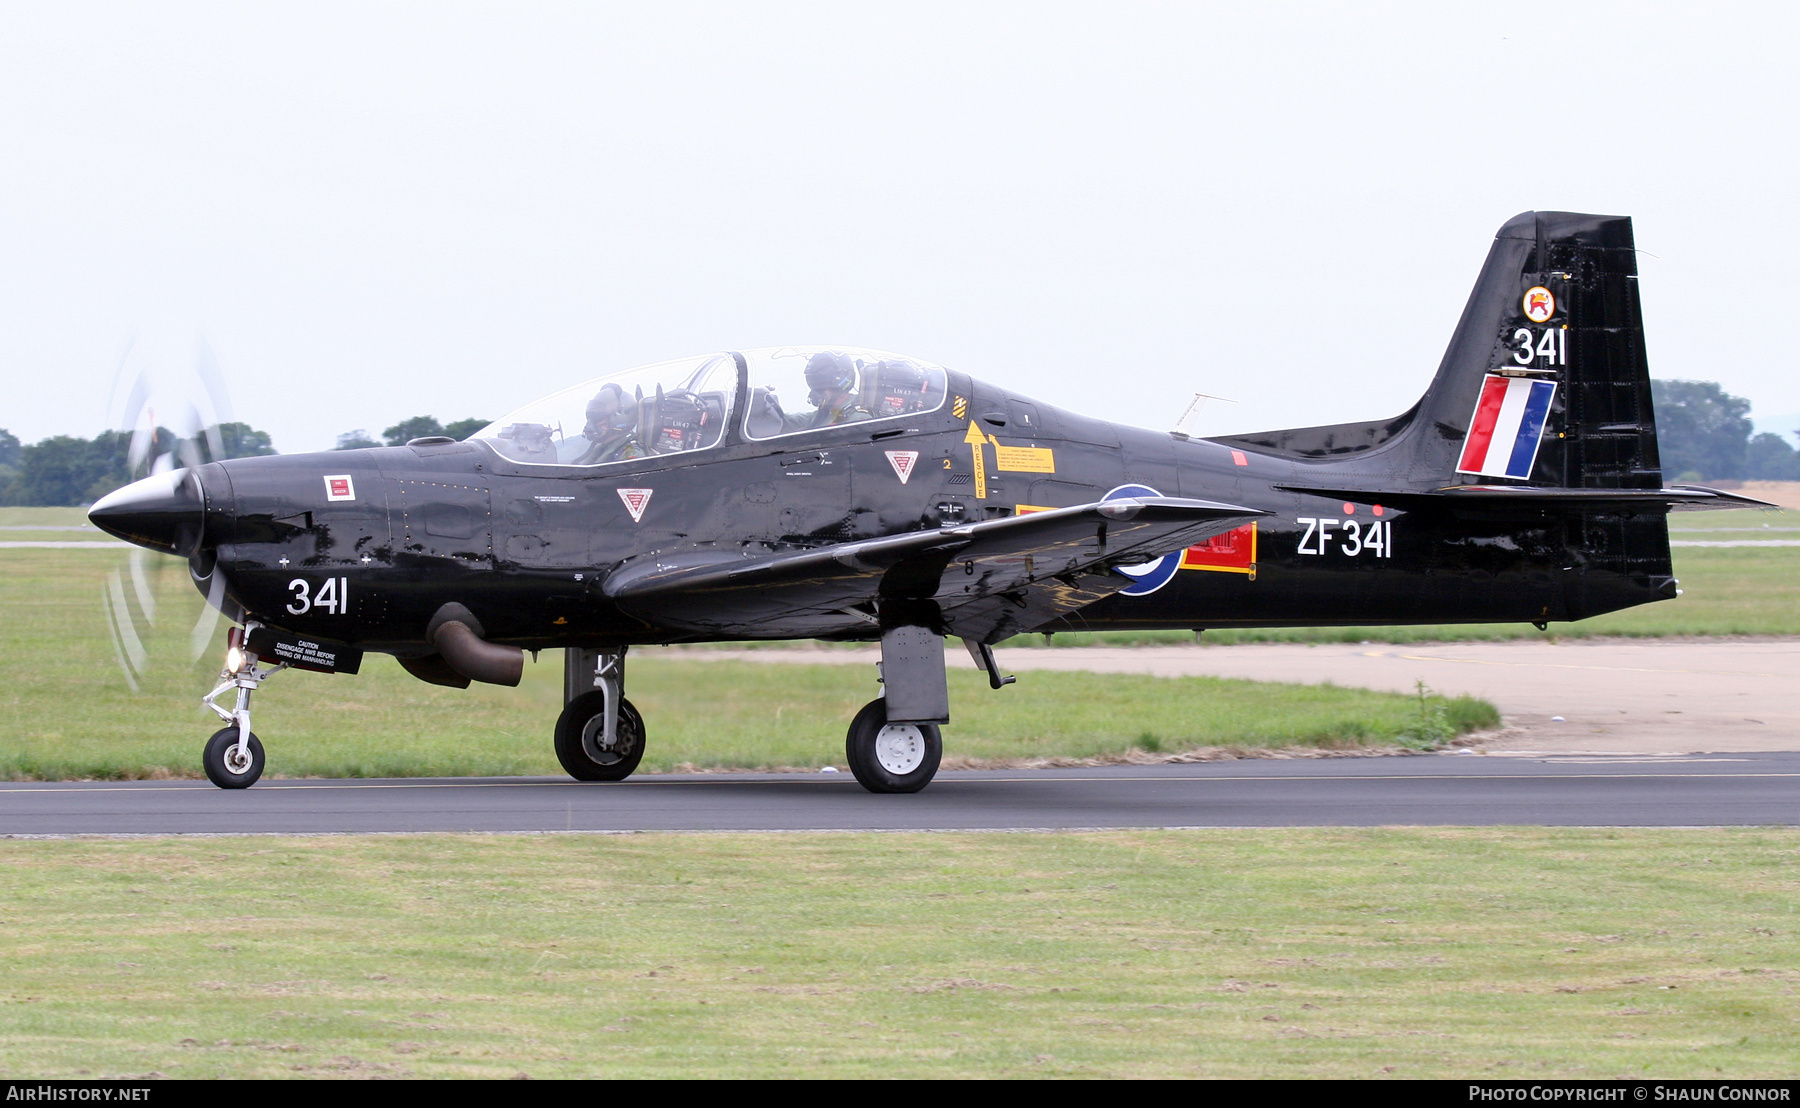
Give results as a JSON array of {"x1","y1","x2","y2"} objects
[{"x1": 1217, "y1": 212, "x2": 1661, "y2": 491}]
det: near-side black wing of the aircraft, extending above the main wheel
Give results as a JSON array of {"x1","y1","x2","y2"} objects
[{"x1": 603, "y1": 496, "x2": 1269, "y2": 642}]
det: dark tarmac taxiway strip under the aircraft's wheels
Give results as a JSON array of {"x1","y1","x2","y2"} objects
[{"x1": 0, "y1": 752, "x2": 1800, "y2": 836}]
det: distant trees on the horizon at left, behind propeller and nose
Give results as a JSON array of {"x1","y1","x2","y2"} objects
[{"x1": 0, "y1": 416, "x2": 488, "y2": 507}]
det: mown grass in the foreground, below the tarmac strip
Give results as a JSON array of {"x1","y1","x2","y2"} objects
[{"x1": 0, "y1": 829, "x2": 1800, "y2": 1079}]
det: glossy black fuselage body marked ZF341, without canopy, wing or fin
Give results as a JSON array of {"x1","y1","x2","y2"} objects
[{"x1": 169, "y1": 359, "x2": 1672, "y2": 653}]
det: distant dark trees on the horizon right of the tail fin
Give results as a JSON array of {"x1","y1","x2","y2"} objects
[{"x1": 1651, "y1": 381, "x2": 1800, "y2": 482}]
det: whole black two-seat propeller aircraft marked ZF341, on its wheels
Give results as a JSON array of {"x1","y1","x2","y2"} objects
[{"x1": 90, "y1": 212, "x2": 1768, "y2": 791}]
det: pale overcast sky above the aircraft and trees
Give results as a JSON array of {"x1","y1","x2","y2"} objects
[{"x1": 0, "y1": 0, "x2": 1800, "y2": 451}]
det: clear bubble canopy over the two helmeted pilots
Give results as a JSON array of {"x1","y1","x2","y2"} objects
[{"x1": 472, "y1": 347, "x2": 947, "y2": 466}]
